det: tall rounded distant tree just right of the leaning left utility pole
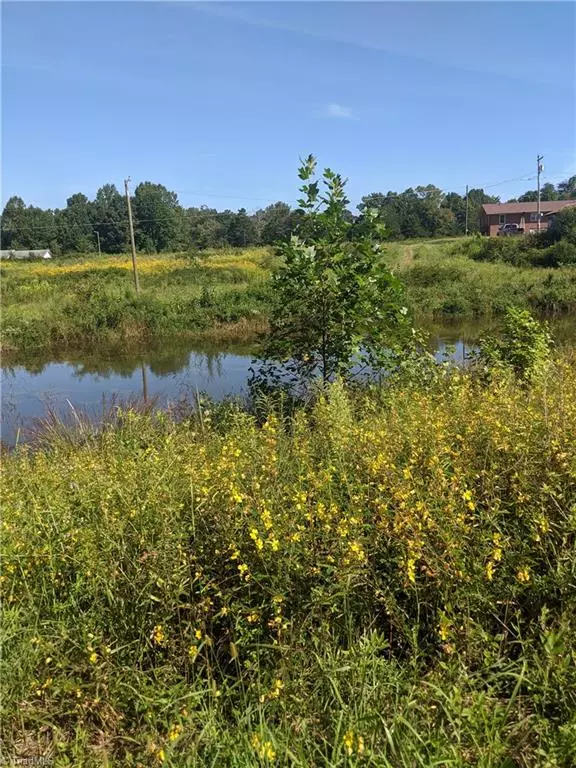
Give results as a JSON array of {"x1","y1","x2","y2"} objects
[{"x1": 132, "y1": 181, "x2": 184, "y2": 251}]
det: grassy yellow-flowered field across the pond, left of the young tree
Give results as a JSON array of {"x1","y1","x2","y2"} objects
[{"x1": 2, "y1": 249, "x2": 274, "y2": 353}]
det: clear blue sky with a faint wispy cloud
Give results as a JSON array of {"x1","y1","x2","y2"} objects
[{"x1": 2, "y1": 1, "x2": 576, "y2": 210}]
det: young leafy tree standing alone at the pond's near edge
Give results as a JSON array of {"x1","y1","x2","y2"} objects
[{"x1": 258, "y1": 155, "x2": 407, "y2": 388}]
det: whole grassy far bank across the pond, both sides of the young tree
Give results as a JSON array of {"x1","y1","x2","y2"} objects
[{"x1": 2, "y1": 239, "x2": 576, "y2": 353}]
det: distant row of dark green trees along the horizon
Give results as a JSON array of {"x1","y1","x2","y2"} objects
[{"x1": 1, "y1": 176, "x2": 576, "y2": 255}]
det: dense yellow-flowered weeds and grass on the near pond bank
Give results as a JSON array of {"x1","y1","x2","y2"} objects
[{"x1": 0, "y1": 351, "x2": 576, "y2": 768}]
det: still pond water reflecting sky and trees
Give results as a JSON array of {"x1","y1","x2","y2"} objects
[{"x1": 2, "y1": 325, "x2": 565, "y2": 446}]
